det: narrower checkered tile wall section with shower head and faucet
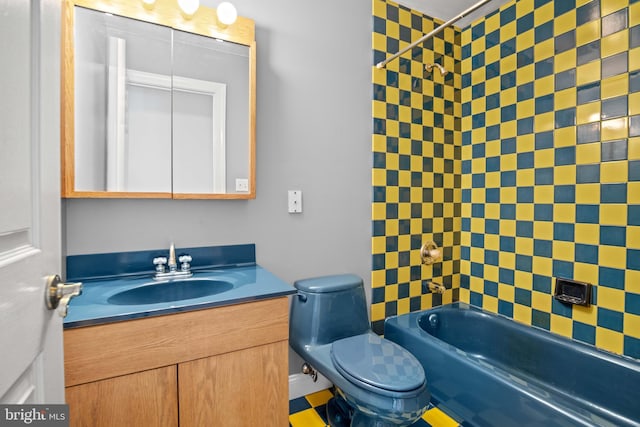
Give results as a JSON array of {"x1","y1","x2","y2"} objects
[{"x1": 371, "y1": 0, "x2": 462, "y2": 333}]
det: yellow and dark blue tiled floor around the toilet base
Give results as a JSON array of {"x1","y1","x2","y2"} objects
[{"x1": 289, "y1": 390, "x2": 458, "y2": 427}]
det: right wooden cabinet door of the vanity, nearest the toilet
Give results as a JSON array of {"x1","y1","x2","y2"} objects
[{"x1": 178, "y1": 341, "x2": 289, "y2": 427}]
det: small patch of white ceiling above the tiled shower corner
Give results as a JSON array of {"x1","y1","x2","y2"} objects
[{"x1": 397, "y1": 0, "x2": 511, "y2": 28}]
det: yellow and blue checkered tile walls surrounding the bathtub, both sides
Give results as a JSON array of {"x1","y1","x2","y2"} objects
[{"x1": 372, "y1": 0, "x2": 640, "y2": 358}]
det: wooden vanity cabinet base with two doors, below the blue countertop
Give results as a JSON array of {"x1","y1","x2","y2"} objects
[{"x1": 64, "y1": 297, "x2": 289, "y2": 427}]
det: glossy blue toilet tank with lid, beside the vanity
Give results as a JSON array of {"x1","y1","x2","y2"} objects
[{"x1": 289, "y1": 274, "x2": 370, "y2": 352}]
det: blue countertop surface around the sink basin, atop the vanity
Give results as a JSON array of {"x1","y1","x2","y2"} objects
[{"x1": 64, "y1": 265, "x2": 296, "y2": 329}]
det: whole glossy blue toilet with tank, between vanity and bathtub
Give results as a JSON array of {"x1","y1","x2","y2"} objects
[{"x1": 289, "y1": 274, "x2": 430, "y2": 427}]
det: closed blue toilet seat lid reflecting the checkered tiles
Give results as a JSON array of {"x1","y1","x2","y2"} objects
[{"x1": 331, "y1": 333, "x2": 425, "y2": 396}]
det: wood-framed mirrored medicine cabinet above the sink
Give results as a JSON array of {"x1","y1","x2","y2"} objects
[{"x1": 61, "y1": 0, "x2": 256, "y2": 199}]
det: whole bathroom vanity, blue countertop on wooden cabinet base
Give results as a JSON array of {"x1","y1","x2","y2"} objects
[{"x1": 64, "y1": 245, "x2": 294, "y2": 427}]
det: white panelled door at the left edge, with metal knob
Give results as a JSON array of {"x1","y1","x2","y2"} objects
[{"x1": 0, "y1": 0, "x2": 64, "y2": 404}]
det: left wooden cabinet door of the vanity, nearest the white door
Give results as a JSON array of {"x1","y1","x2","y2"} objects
[{"x1": 66, "y1": 365, "x2": 178, "y2": 427}]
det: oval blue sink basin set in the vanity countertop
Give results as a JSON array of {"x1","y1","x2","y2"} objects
[{"x1": 107, "y1": 279, "x2": 233, "y2": 305}]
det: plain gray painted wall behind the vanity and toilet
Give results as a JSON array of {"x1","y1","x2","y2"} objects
[{"x1": 63, "y1": 0, "x2": 372, "y2": 372}]
